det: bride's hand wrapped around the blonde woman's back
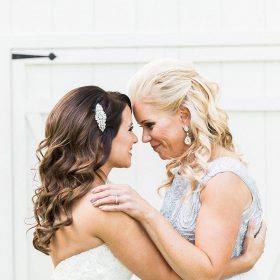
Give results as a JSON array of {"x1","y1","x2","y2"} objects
[{"x1": 241, "y1": 221, "x2": 266, "y2": 270}]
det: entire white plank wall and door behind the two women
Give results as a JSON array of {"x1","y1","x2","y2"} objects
[{"x1": 0, "y1": 0, "x2": 280, "y2": 280}]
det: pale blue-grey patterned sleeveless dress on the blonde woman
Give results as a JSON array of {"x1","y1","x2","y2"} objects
[{"x1": 161, "y1": 157, "x2": 262, "y2": 280}]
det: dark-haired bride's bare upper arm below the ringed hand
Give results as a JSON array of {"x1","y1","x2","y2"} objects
[{"x1": 87, "y1": 199, "x2": 181, "y2": 280}]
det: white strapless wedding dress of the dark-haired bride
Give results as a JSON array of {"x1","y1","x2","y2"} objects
[{"x1": 52, "y1": 244, "x2": 132, "y2": 280}]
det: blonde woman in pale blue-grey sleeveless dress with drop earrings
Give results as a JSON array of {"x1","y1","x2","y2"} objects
[{"x1": 91, "y1": 60, "x2": 265, "y2": 280}]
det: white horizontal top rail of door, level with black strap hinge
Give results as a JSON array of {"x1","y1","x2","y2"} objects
[{"x1": 9, "y1": 46, "x2": 280, "y2": 66}]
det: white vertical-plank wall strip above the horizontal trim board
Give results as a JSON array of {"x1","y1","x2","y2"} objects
[{"x1": 0, "y1": 0, "x2": 280, "y2": 34}]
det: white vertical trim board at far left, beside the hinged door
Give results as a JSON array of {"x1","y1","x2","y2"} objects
[{"x1": 0, "y1": 42, "x2": 14, "y2": 279}]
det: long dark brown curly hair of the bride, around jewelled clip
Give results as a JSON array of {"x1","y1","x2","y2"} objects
[{"x1": 32, "y1": 86, "x2": 131, "y2": 255}]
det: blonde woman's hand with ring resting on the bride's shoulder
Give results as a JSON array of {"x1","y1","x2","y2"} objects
[{"x1": 90, "y1": 184, "x2": 153, "y2": 221}]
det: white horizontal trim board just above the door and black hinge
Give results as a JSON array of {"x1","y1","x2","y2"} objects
[{"x1": 2, "y1": 31, "x2": 280, "y2": 49}]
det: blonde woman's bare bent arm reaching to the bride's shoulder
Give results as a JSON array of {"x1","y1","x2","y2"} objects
[{"x1": 91, "y1": 173, "x2": 256, "y2": 279}]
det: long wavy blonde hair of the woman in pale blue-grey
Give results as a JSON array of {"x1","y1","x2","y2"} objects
[{"x1": 128, "y1": 59, "x2": 235, "y2": 191}]
